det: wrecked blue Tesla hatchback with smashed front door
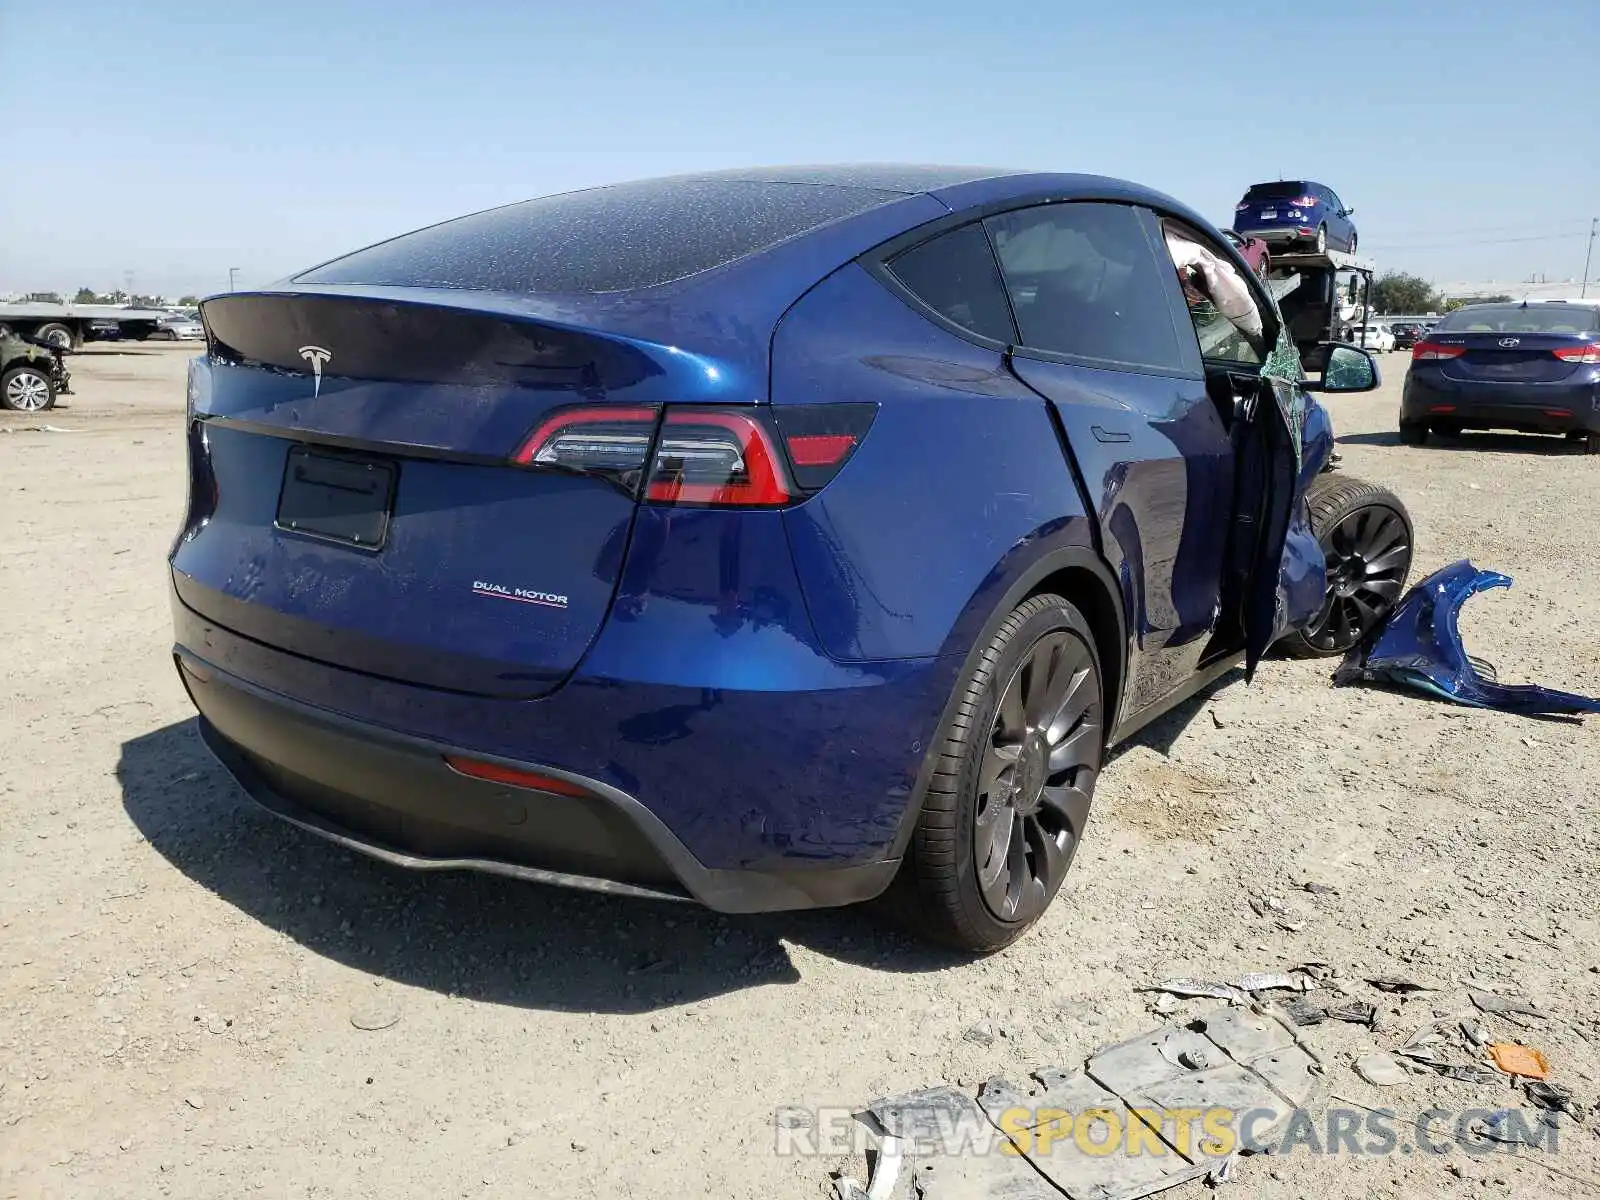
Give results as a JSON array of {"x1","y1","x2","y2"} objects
[{"x1": 171, "y1": 166, "x2": 1410, "y2": 949}]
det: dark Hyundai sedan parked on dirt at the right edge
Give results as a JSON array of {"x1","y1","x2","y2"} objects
[{"x1": 1400, "y1": 301, "x2": 1600, "y2": 454}]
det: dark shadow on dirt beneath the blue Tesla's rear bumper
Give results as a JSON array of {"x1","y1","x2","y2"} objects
[{"x1": 117, "y1": 720, "x2": 971, "y2": 1013}]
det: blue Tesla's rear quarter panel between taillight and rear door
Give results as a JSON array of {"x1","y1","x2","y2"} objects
[{"x1": 771, "y1": 264, "x2": 1093, "y2": 662}]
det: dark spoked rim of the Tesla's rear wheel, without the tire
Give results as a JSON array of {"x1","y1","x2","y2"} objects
[{"x1": 973, "y1": 632, "x2": 1104, "y2": 922}]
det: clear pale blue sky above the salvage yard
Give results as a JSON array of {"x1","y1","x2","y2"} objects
[{"x1": 0, "y1": 0, "x2": 1600, "y2": 293}]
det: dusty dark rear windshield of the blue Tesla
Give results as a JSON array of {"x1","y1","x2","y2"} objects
[{"x1": 296, "y1": 179, "x2": 902, "y2": 293}]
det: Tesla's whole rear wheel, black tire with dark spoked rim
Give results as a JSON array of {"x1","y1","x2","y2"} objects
[{"x1": 888, "y1": 595, "x2": 1106, "y2": 952}]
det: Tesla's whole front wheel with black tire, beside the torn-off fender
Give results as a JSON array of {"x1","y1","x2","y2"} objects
[{"x1": 1278, "y1": 475, "x2": 1416, "y2": 658}]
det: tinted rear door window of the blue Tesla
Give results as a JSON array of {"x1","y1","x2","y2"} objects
[{"x1": 986, "y1": 203, "x2": 1181, "y2": 368}]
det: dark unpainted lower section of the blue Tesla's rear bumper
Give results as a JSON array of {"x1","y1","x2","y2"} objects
[{"x1": 174, "y1": 646, "x2": 899, "y2": 912}]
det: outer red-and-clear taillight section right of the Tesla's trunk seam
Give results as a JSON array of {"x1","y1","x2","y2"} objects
[{"x1": 645, "y1": 408, "x2": 792, "y2": 507}]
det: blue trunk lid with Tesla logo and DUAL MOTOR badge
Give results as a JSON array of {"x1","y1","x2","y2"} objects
[{"x1": 173, "y1": 293, "x2": 717, "y2": 698}]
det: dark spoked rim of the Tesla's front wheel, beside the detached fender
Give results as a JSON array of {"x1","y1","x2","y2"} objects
[{"x1": 1306, "y1": 506, "x2": 1411, "y2": 650}]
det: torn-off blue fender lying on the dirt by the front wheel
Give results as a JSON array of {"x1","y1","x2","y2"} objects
[{"x1": 1333, "y1": 558, "x2": 1600, "y2": 715}]
